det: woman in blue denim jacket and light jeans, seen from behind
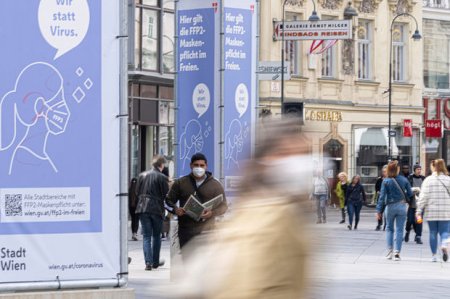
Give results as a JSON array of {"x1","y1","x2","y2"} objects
[{"x1": 377, "y1": 161, "x2": 413, "y2": 261}]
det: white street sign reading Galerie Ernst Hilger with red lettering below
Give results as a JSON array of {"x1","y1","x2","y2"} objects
[{"x1": 273, "y1": 20, "x2": 352, "y2": 40}]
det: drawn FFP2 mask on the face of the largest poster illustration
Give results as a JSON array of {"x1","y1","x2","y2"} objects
[{"x1": 45, "y1": 99, "x2": 70, "y2": 135}]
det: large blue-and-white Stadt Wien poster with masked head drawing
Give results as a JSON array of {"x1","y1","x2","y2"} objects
[{"x1": 0, "y1": 0, "x2": 120, "y2": 290}]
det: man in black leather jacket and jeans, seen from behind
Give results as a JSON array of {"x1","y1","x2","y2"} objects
[{"x1": 136, "y1": 155, "x2": 169, "y2": 271}]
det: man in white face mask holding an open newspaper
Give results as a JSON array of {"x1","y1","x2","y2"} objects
[{"x1": 166, "y1": 153, "x2": 228, "y2": 252}]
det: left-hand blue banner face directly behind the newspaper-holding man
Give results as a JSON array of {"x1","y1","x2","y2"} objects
[{"x1": 175, "y1": 0, "x2": 220, "y2": 176}]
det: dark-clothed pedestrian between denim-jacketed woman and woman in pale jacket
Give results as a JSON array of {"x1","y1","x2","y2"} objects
[{"x1": 405, "y1": 164, "x2": 425, "y2": 244}]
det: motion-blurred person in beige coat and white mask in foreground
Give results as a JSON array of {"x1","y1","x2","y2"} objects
[{"x1": 171, "y1": 122, "x2": 313, "y2": 299}]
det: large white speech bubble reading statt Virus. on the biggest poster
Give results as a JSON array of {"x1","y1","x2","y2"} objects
[{"x1": 38, "y1": 0, "x2": 90, "y2": 59}]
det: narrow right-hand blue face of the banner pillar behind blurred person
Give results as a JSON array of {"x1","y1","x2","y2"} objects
[{"x1": 222, "y1": 0, "x2": 257, "y2": 196}]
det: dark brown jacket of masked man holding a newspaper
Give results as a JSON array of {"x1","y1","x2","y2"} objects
[{"x1": 166, "y1": 172, "x2": 228, "y2": 231}]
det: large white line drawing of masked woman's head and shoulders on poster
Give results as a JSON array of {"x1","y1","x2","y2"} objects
[{"x1": 0, "y1": 62, "x2": 70, "y2": 175}]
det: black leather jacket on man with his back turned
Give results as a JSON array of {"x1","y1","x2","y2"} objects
[{"x1": 136, "y1": 168, "x2": 169, "y2": 217}]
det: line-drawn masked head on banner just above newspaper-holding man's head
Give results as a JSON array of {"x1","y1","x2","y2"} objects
[{"x1": 180, "y1": 119, "x2": 203, "y2": 169}]
